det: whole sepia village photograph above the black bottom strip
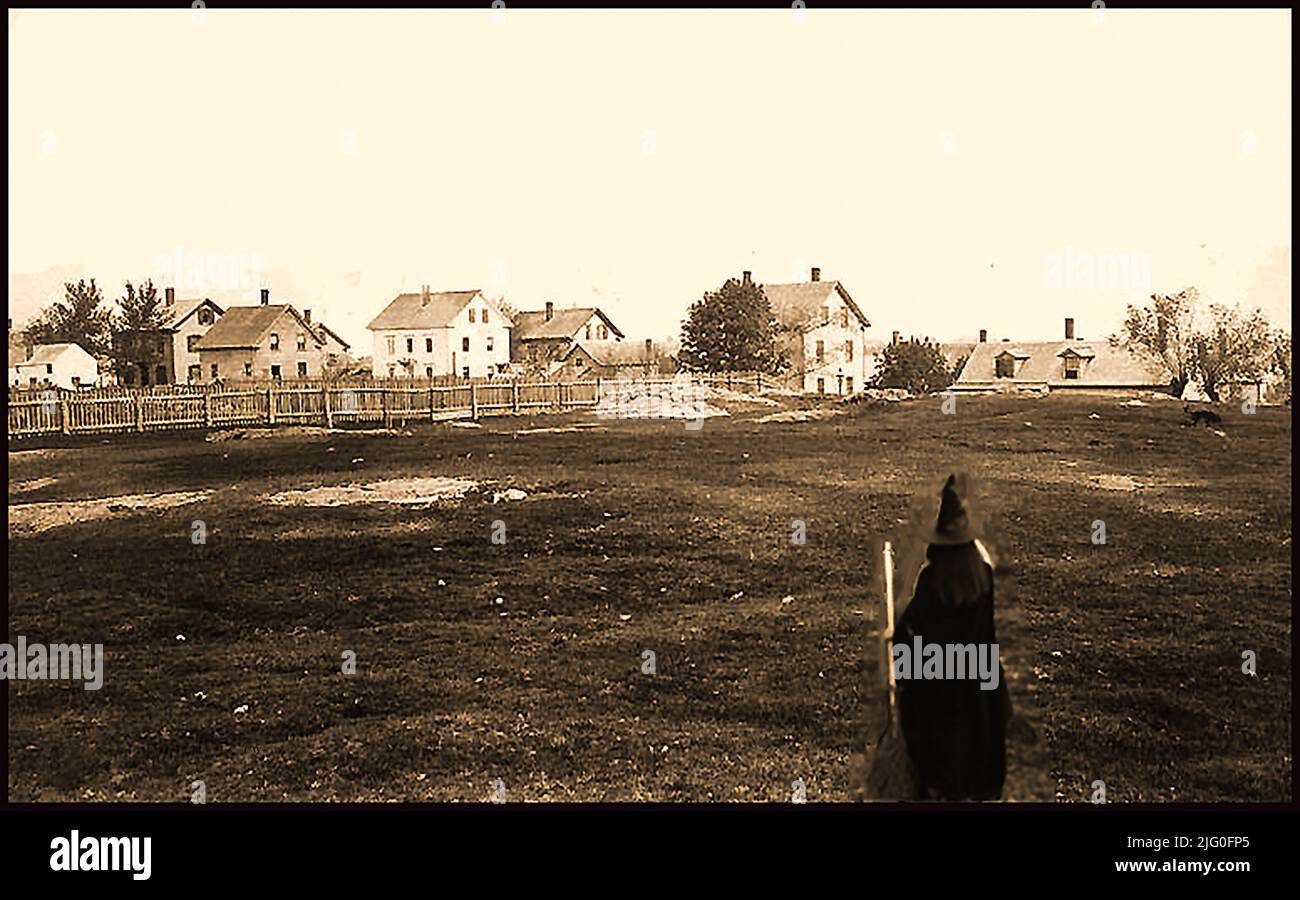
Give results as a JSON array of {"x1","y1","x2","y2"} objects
[{"x1": 0, "y1": 0, "x2": 1295, "y2": 890}]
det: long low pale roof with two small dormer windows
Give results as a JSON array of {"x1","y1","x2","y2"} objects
[{"x1": 956, "y1": 341, "x2": 1169, "y2": 388}]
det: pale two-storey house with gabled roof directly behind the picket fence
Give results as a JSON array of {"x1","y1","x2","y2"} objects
[{"x1": 367, "y1": 285, "x2": 514, "y2": 378}]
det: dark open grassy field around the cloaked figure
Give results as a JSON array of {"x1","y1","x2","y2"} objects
[{"x1": 8, "y1": 395, "x2": 1292, "y2": 802}]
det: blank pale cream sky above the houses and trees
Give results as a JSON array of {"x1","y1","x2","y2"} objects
[{"x1": 9, "y1": 9, "x2": 1291, "y2": 354}]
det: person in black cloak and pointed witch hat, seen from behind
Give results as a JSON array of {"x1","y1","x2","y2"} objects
[{"x1": 894, "y1": 475, "x2": 1011, "y2": 800}]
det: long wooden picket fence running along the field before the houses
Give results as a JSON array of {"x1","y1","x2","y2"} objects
[{"x1": 8, "y1": 376, "x2": 743, "y2": 438}]
